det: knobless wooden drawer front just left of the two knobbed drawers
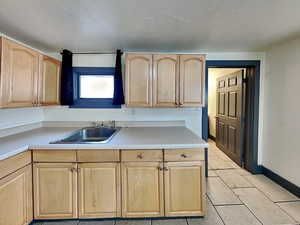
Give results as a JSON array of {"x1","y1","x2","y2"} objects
[{"x1": 77, "y1": 149, "x2": 120, "y2": 162}]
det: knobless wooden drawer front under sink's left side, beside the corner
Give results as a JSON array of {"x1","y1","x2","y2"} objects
[{"x1": 33, "y1": 150, "x2": 76, "y2": 162}]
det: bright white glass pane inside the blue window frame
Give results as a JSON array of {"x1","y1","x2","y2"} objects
[{"x1": 80, "y1": 75, "x2": 114, "y2": 98}]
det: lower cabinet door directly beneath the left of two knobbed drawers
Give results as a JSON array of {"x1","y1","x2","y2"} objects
[{"x1": 122, "y1": 162, "x2": 164, "y2": 217}]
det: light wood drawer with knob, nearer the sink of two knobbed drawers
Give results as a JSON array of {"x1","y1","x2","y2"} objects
[{"x1": 121, "y1": 149, "x2": 163, "y2": 162}]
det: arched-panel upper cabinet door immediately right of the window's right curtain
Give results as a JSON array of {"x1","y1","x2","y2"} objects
[{"x1": 125, "y1": 54, "x2": 152, "y2": 107}]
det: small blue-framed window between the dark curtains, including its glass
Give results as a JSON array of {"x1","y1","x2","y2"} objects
[{"x1": 71, "y1": 67, "x2": 121, "y2": 108}]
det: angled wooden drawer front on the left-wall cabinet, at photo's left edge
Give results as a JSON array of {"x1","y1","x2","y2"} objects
[{"x1": 0, "y1": 151, "x2": 31, "y2": 179}]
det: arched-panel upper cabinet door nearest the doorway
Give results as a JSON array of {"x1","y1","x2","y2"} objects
[{"x1": 179, "y1": 55, "x2": 205, "y2": 107}]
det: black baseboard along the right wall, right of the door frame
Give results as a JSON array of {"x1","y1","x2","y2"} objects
[{"x1": 261, "y1": 166, "x2": 300, "y2": 198}]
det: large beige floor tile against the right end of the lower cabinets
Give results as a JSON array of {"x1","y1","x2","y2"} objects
[{"x1": 207, "y1": 177, "x2": 241, "y2": 205}]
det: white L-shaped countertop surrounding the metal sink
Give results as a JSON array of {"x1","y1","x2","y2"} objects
[{"x1": 0, "y1": 127, "x2": 208, "y2": 160}]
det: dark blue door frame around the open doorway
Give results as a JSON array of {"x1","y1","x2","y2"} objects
[{"x1": 202, "y1": 60, "x2": 261, "y2": 174}]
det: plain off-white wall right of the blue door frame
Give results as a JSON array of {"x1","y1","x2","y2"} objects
[{"x1": 262, "y1": 39, "x2": 300, "y2": 186}]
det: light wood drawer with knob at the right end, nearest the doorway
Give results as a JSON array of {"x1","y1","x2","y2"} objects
[{"x1": 165, "y1": 149, "x2": 204, "y2": 162}]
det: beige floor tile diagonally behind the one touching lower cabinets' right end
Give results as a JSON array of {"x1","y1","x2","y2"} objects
[{"x1": 215, "y1": 169, "x2": 254, "y2": 188}]
